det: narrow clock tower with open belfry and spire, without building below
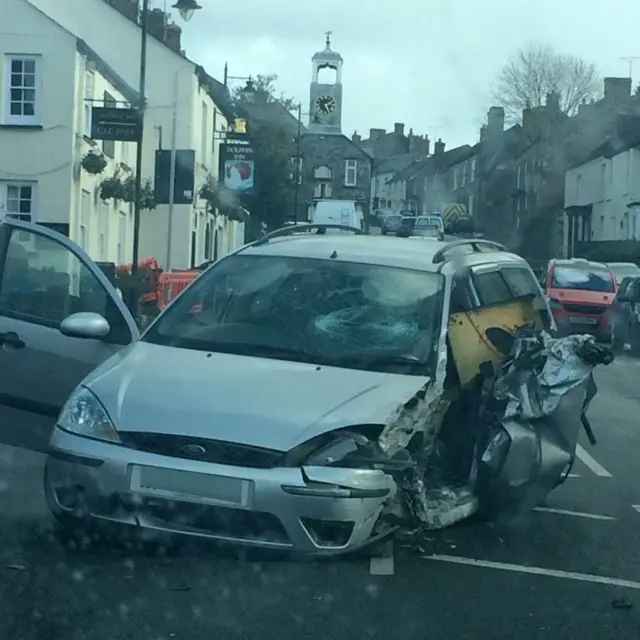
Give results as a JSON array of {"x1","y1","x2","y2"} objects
[{"x1": 309, "y1": 31, "x2": 343, "y2": 135}]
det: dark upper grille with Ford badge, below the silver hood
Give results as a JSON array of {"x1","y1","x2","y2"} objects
[{"x1": 120, "y1": 431, "x2": 284, "y2": 469}]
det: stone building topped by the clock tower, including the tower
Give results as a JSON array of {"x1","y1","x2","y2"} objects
[{"x1": 295, "y1": 33, "x2": 372, "y2": 221}]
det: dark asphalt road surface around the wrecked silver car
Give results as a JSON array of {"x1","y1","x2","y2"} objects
[{"x1": 0, "y1": 358, "x2": 640, "y2": 640}]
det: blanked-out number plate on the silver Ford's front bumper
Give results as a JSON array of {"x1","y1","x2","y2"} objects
[{"x1": 130, "y1": 465, "x2": 252, "y2": 507}]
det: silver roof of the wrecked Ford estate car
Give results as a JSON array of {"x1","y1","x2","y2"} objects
[{"x1": 241, "y1": 233, "x2": 527, "y2": 272}]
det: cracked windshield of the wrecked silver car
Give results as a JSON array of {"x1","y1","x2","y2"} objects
[{"x1": 143, "y1": 255, "x2": 443, "y2": 374}]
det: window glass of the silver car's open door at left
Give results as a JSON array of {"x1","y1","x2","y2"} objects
[{"x1": 0, "y1": 229, "x2": 132, "y2": 344}]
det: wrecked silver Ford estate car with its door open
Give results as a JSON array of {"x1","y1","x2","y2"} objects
[{"x1": 0, "y1": 221, "x2": 609, "y2": 554}]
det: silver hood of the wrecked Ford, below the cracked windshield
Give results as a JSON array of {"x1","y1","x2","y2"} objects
[{"x1": 84, "y1": 342, "x2": 429, "y2": 451}]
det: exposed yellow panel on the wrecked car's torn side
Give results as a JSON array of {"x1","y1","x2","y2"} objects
[{"x1": 449, "y1": 299, "x2": 542, "y2": 385}]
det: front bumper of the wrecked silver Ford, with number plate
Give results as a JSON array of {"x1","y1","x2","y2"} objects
[{"x1": 45, "y1": 428, "x2": 396, "y2": 555}]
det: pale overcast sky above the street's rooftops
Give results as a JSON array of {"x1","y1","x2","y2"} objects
[{"x1": 169, "y1": 0, "x2": 640, "y2": 148}]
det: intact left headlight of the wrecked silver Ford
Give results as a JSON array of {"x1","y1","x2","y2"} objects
[{"x1": 58, "y1": 387, "x2": 120, "y2": 443}]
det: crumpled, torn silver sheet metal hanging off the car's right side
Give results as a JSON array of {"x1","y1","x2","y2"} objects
[{"x1": 477, "y1": 327, "x2": 613, "y2": 517}]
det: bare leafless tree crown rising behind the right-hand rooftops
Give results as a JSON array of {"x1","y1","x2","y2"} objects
[{"x1": 492, "y1": 42, "x2": 600, "y2": 122}]
